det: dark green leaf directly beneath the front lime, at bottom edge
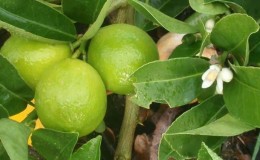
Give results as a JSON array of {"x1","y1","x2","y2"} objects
[{"x1": 32, "y1": 129, "x2": 78, "y2": 160}]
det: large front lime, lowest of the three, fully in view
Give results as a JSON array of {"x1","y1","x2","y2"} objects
[{"x1": 35, "y1": 59, "x2": 106, "y2": 136}]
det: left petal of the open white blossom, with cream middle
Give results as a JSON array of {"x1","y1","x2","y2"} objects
[{"x1": 201, "y1": 64, "x2": 221, "y2": 88}]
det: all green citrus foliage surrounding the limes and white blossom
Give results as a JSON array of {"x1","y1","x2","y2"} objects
[{"x1": 0, "y1": 0, "x2": 260, "y2": 160}]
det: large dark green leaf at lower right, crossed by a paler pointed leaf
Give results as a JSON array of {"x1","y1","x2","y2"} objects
[{"x1": 159, "y1": 95, "x2": 227, "y2": 160}]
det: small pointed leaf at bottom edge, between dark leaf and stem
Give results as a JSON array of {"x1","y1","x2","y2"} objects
[{"x1": 70, "y1": 136, "x2": 102, "y2": 160}]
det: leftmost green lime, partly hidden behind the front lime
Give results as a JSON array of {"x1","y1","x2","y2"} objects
[{"x1": 1, "y1": 36, "x2": 71, "y2": 89}]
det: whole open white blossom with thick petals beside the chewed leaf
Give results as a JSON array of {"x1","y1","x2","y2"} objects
[{"x1": 201, "y1": 64, "x2": 233, "y2": 94}]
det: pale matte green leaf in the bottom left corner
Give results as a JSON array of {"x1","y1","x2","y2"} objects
[{"x1": 0, "y1": 118, "x2": 30, "y2": 160}]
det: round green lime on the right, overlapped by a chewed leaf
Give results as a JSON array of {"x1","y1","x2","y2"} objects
[{"x1": 88, "y1": 24, "x2": 158, "y2": 94}]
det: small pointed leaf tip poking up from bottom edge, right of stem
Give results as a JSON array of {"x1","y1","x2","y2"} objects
[{"x1": 197, "y1": 142, "x2": 222, "y2": 160}]
